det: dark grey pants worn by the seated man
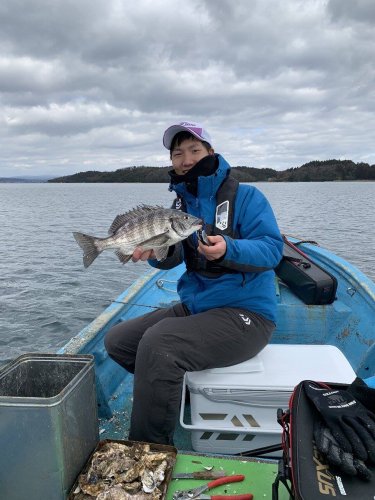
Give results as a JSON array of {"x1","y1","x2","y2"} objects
[{"x1": 104, "y1": 303, "x2": 275, "y2": 444}]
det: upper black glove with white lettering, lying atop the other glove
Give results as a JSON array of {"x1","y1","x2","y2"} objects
[{"x1": 303, "y1": 381, "x2": 375, "y2": 463}]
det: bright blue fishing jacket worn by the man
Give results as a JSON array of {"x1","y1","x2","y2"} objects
[{"x1": 149, "y1": 155, "x2": 283, "y2": 323}]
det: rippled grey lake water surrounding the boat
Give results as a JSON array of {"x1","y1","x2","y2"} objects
[{"x1": 0, "y1": 182, "x2": 375, "y2": 362}]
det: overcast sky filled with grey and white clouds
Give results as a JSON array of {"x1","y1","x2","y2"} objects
[{"x1": 0, "y1": 0, "x2": 375, "y2": 177}]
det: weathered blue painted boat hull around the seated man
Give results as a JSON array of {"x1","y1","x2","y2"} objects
[{"x1": 59, "y1": 240, "x2": 375, "y2": 449}]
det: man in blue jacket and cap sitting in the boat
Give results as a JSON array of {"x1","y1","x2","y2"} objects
[{"x1": 105, "y1": 122, "x2": 283, "y2": 444}]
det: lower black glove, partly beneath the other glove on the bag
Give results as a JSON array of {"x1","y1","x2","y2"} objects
[{"x1": 313, "y1": 417, "x2": 372, "y2": 480}]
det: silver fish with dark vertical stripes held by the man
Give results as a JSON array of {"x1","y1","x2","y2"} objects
[{"x1": 73, "y1": 205, "x2": 202, "y2": 267}]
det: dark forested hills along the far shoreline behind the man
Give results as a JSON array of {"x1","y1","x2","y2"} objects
[{"x1": 48, "y1": 160, "x2": 375, "y2": 183}]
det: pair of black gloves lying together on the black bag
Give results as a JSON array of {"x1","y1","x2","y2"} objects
[{"x1": 303, "y1": 381, "x2": 375, "y2": 479}]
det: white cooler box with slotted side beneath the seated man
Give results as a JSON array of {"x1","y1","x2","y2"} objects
[{"x1": 180, "y1": 344, "x2": 356, "y2": 456}]
